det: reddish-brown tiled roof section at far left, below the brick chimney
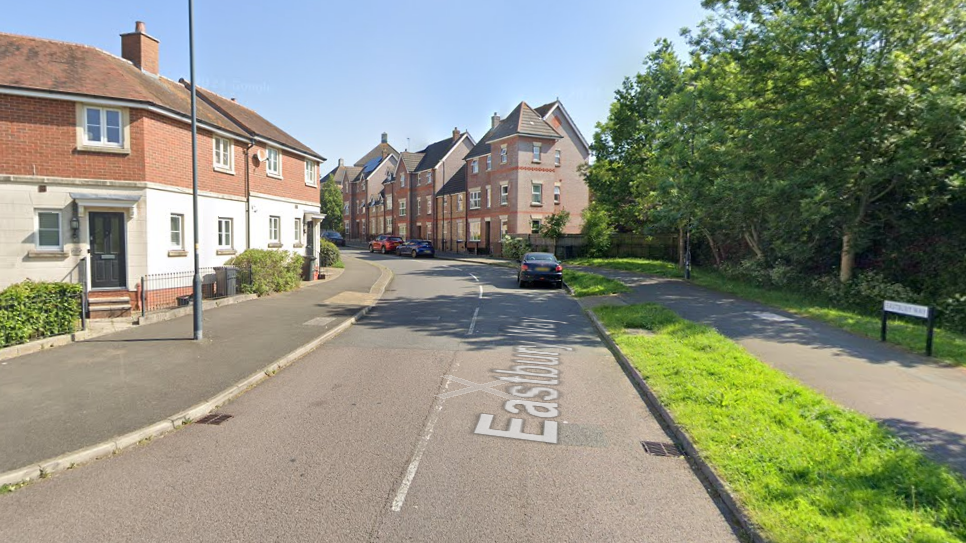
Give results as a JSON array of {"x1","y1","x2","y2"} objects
[{"x1": 0, "y1": 33, "x2": 247, "y2": 137}]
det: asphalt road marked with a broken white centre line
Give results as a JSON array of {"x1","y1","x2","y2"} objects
[{"x1": 0, "y1": 255, "x2": 737, "y2": 542}]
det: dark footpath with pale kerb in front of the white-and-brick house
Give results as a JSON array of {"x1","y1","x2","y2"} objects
[{"x1": 0, "y1": 254, "x2": 391, "y2": 483}]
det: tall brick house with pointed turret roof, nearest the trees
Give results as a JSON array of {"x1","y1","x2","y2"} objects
[{"x1": 462, "y1": 100, "x2": 590, "y2": 254}]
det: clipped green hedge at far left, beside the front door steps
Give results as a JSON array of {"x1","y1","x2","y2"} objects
[{"x1": 0, "y1": 280, "x2": 82, "y2": 347}]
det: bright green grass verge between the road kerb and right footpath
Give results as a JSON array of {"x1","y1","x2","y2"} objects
[{"x1": 594, "y1": 304, "x2": 966, "y2": 543}]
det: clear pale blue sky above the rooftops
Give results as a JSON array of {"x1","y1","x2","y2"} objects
[{"x1": 0, "y1": 0, "x2": 708, "y2": 172}]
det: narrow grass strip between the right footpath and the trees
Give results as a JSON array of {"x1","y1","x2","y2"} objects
[{"x1": 567, "y1": 258, "x2": 966, "y2": 366}]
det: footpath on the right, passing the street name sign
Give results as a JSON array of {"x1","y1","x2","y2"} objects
[{"x1": 571, "y1": 266, "x2": 966, "y2": 475}]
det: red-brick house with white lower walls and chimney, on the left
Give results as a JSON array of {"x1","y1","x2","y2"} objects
[{"x1": 0, "y1": 22, "x2": 325, "y2": 317}]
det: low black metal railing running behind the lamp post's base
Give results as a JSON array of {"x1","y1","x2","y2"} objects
[{"x1": 141, "y1": 266, "x2": 252, "y2": 315}]
